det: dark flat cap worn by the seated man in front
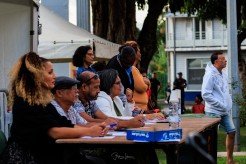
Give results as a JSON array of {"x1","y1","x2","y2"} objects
[{"x1": 51, "y1": 76, "x2": 80, "y2": 93}]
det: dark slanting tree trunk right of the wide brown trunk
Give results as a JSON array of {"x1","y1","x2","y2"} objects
[{"x1": 137, "y1": 0, "x2": 167, "y2": 70}]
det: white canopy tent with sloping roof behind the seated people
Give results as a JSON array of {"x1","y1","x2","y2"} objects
[{"x1": 38, "y1": 5, "x2": 119, "y2": 62}]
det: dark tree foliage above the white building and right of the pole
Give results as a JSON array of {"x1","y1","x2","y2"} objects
[{"x1": 169, "y1": 0, "x2": 246, "y2": 99}]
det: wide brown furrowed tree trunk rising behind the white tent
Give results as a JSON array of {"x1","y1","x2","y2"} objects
[{"x1": 91, "y1": 0, "x2": 136, "y2": 44}]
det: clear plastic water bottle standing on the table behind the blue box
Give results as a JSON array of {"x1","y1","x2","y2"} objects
[{"x1": 168, "y1": 102, "x2": 180, "y2": 129}]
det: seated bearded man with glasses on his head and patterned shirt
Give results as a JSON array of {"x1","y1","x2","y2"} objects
[{"x1": 73, "y1": 71, "x2": 145, "y2": 129}]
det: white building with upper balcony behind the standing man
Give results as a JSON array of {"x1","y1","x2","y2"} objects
[{"x1": 165, "y1": 13, "x2": 246, "y2": 101}]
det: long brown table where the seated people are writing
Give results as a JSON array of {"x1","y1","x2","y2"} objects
[{"x1": 56, "y1": 117, "x2": 220, "y2": 164}]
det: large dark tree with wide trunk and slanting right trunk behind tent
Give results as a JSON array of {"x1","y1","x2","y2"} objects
[{"x1": 91, "y1": 0, "x2": 168, "y2": 69}]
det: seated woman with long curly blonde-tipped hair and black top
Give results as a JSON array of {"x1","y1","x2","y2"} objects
[{"x1": 0, "y1": 52, "x2": 105, "y2": 164}]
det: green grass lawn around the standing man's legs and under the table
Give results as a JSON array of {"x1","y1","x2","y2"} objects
[{"x1": 156, "y1": 127, "x2": 246, "y2": 164}]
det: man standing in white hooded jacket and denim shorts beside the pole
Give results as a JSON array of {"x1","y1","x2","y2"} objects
[{"x1": 202, "y1": 52, "x2": 236, "y2": 164}]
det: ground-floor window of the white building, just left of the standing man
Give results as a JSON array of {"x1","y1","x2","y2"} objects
[{"x1": 187, "y1": 58, "x2": 210, "y2": 90}]
